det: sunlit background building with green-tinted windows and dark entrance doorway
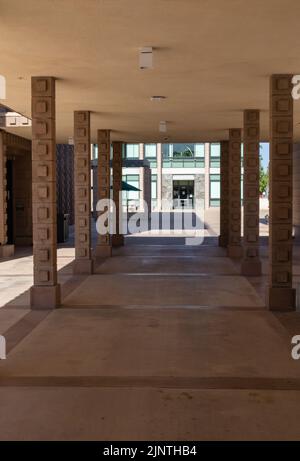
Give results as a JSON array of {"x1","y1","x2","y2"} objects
[{"x1": 123, "y1": 143, "x2": 227, "y2": 209}]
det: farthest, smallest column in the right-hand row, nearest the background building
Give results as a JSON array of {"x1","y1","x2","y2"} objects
[{"x1": 219, "y1": 141, "x2": 229, "y2": 248}]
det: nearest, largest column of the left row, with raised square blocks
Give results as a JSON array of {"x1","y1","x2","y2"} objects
[{"x1": 30, "y1": 77, "x2": 60, "y2": 309}]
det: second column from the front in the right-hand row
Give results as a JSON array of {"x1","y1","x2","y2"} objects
[{"x1": 241, "y1": 110, "x2": 261, "y2": 275}]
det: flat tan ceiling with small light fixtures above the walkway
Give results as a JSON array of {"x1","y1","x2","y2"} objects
[{"x1": 0, "y1": 0, "x2": 300, "y2": 142}]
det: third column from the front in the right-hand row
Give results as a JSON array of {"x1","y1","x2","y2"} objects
[{"x1": 227, "y1": 128, "x2": 242, "y2": 258}]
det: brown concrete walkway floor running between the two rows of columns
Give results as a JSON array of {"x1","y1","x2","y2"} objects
[{"x1": 0, "y1": 237, "x2": 300, "y2": 440}]
